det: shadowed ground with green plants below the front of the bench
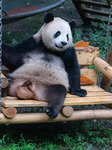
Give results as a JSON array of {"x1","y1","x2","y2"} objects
[{"x1": 0, "y1": 120, "x2": 112, "y2": 150}]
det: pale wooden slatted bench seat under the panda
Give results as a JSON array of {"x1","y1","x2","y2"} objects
[{"x1": 2, "y1": 86, "x2": 112, "y2": 107}]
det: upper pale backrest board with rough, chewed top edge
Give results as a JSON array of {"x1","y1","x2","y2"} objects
[{"x1": 75, "y1": 46, "x2": 99, "y2": 65}]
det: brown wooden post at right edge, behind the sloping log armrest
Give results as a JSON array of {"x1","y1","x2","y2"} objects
[{"x1": 101, "y1": 44, "x2": 112, "y2": 91}]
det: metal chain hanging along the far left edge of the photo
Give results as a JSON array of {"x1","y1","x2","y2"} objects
[{"x1": 0, "y1": 0, "x2": 2, "y2": 112}]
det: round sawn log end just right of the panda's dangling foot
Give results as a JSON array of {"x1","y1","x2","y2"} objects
[{"x1": 61, "y1": 106, "x2": 74, "y2": 117}]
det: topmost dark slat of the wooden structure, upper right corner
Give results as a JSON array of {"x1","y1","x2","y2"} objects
[{"x1": 81, "y1": 0, "x2": 110, "y2": 8}]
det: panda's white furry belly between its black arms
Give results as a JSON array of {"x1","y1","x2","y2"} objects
[{"x1": 11, "y1": 53, "x2": 69, "y2": 89}]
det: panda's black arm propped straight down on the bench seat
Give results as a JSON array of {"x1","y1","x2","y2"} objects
[{"x1": 63, "y1": 47, "x2": 87, "y2": 96}]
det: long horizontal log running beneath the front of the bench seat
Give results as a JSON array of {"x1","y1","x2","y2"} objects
[{"x1": 0, "y1": 109, "x2": 112, "y2": 124}]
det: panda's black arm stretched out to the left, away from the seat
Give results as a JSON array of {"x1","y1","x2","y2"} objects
[{"x1": 2, "y1": 37, "x2": 38, "y2": 71}]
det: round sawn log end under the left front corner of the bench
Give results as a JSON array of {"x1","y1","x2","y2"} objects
[{"x1": 1, "y1": 106, "x2": 17, "y2": 119}]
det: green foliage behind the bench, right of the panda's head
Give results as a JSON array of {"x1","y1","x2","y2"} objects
[{"x1": 73, "y1": 23, "x2": 112, "y2": 57}]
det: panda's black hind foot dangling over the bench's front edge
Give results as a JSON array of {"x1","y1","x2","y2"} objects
[{"x1": 45, "y1": 107, "x2": 58, "y2": 119}]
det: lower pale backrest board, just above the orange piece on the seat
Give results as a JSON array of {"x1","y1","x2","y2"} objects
[{"x1": 81, "y1": 69, "x2": 97, "y2": 85}]
